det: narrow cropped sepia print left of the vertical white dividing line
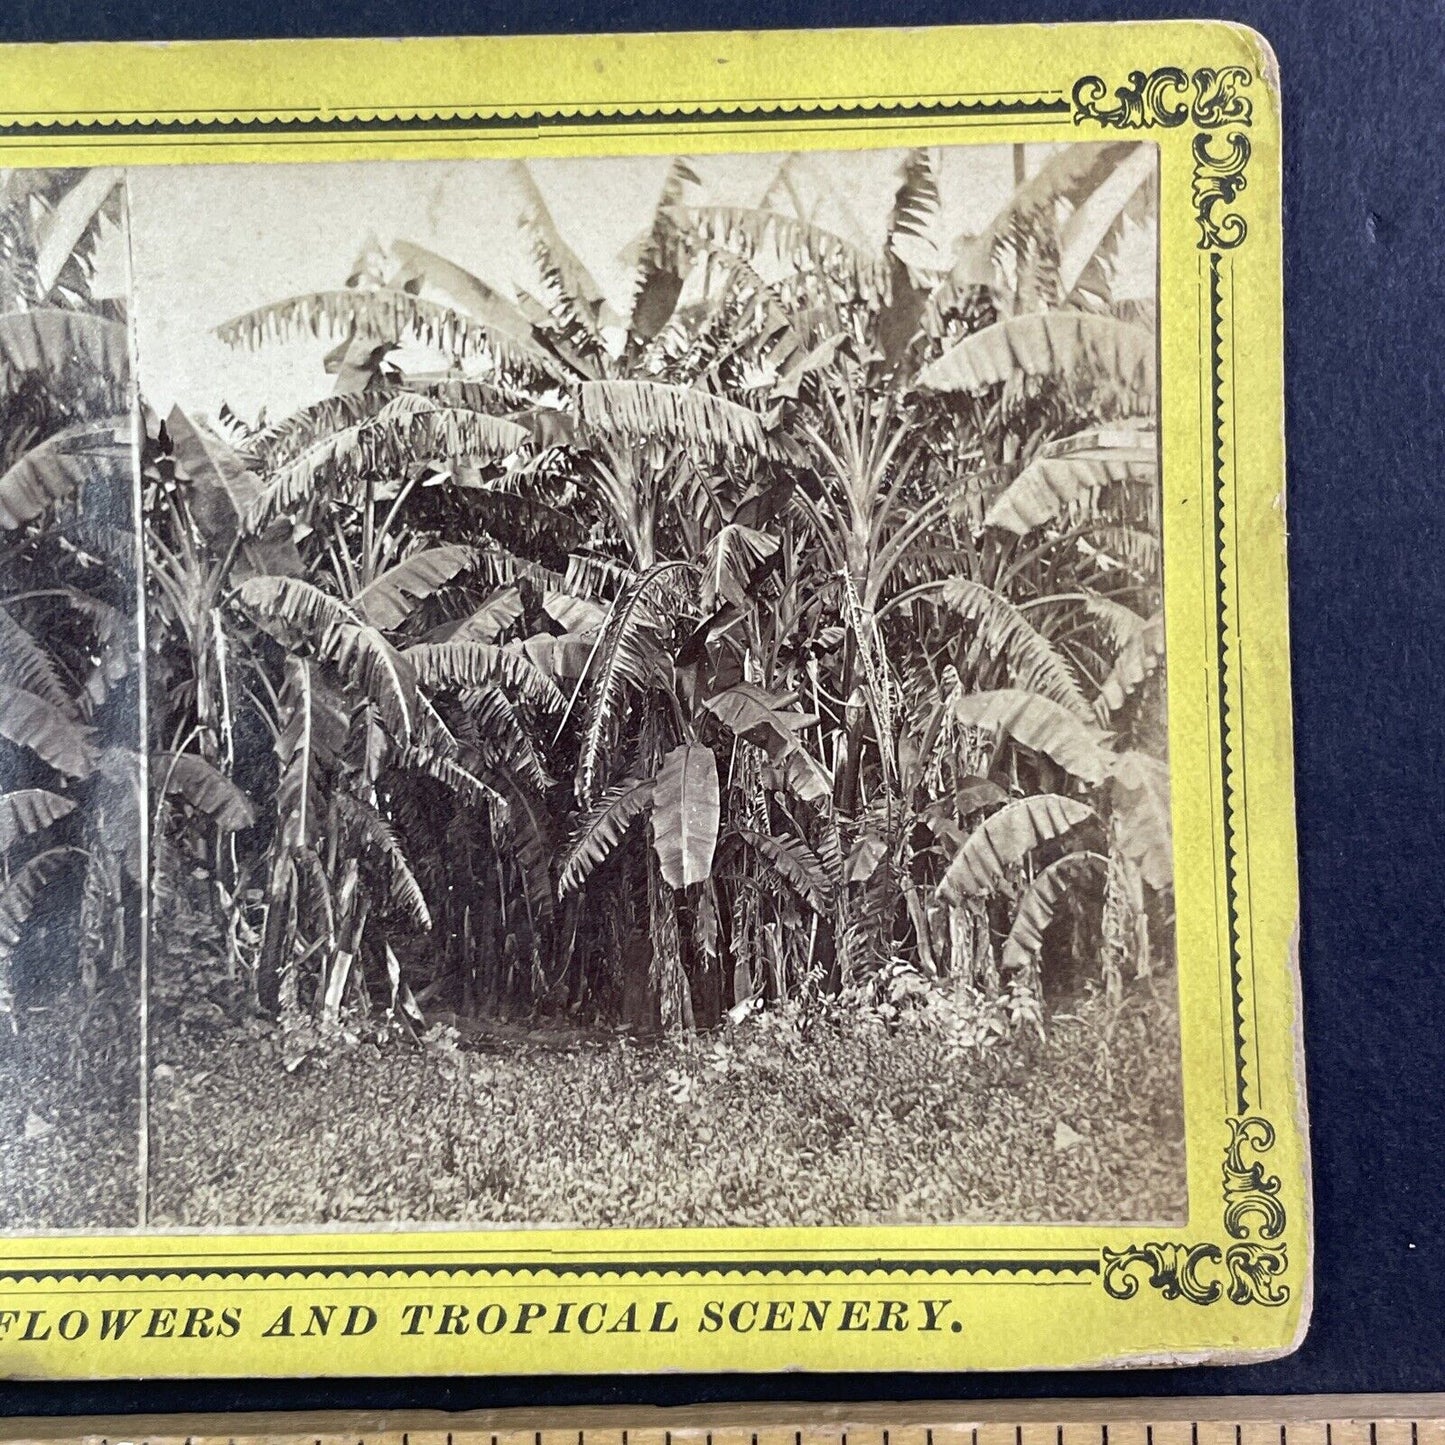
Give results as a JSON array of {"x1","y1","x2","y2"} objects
[{"x1": 0, "y1": 169, "x2": 143, "y2": 1233}]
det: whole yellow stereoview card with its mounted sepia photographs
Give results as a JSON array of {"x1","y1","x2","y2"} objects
[{"x1": 0, "y1": 26, "x2": 1308, "y2": 1374}]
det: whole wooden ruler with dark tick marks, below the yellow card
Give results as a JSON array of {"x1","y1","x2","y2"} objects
[{"x1": 0, "y1": 1394, "x2": 1445, "y2": 1445}]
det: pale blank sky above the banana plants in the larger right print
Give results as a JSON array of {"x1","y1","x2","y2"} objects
[{"x1": 130, "y1": 146, "x2": 1150, "y2": 420}]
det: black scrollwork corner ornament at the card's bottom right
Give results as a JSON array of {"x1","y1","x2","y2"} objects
[{"x1": 1103, "y1": 1114, "x2": 1289, "y2": 1306}]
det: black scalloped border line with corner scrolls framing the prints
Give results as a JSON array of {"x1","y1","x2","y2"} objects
[{"x1": 0, "y1": 65, "x2": 1290, "y2": 1306}]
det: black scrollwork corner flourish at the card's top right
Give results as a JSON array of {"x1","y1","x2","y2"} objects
[{"x1": 1072, "y1": 65, "x2": 1254, "y2": 251}]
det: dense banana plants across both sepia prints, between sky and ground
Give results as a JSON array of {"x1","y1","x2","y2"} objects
[{"x1": 0, "y1": 142, "x2": 1176, "y2": 1222}]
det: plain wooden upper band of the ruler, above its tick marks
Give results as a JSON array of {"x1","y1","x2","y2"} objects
[{"x1": 0, "y1": 1393, "x2": 1445, "y2": 1445}]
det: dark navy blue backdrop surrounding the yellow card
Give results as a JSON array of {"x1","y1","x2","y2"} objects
[{"x1": 0, "y1": 0, "x2": 1445, "y2": 1413}]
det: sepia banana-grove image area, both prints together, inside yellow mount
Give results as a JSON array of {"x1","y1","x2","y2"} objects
[{"x1": 0, "y1": 140, "x2": 1188, "y2": 1230}]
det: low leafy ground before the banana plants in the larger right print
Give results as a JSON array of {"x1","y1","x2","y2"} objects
[{"x1": 152, "y1": 978, "x2": 1185, "y2": 1227}]
